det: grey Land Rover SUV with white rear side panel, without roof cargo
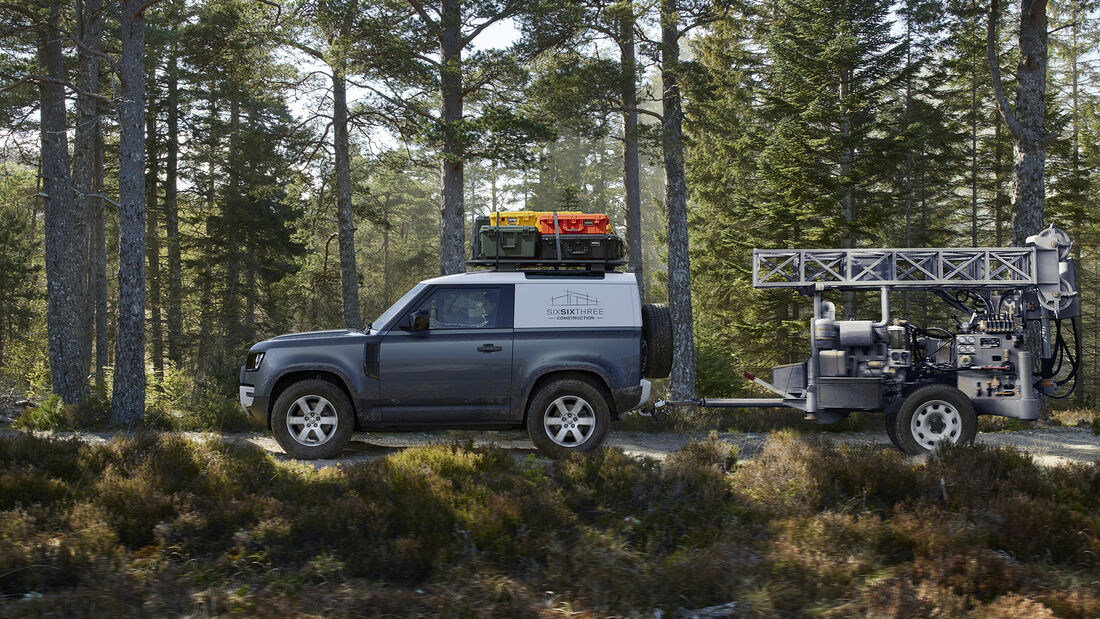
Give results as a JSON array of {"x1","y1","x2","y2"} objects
[{"x1": 240, "y1": 272, "x2": 672, "y2": 458}]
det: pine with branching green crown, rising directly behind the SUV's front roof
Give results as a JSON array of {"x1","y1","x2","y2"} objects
[{"x1": 365, "y1": 0, "x2": 578, "y2": 274}]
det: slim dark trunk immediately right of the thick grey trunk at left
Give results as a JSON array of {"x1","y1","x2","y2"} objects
[{"x1": 145, "y1": 87, "x2": 164, "y2": 378}]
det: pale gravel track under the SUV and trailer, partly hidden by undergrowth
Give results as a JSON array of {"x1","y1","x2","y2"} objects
[{"x1": 10, "y1": 428, "x2": 1100, "y2": 467}]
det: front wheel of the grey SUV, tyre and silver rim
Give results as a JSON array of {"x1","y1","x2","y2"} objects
[{"x1": 272, "y1": 378, "x2": 355, "y2": 460}]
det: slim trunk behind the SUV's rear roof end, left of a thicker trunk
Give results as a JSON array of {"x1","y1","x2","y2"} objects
[{"x1": 619, "y1": 9, "x2": 646, "y2": 302}]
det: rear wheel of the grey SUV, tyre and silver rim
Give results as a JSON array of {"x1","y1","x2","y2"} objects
[{"x1": 527, "y1": 377, "x2": 612, "y2": 457}]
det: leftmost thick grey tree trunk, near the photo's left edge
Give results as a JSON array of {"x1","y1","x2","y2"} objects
[{"x1": 39, "y1": 2, "x2": 88, "y2": 404}]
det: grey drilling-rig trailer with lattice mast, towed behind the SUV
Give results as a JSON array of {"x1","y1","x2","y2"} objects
[{"x1": 655, "y1": 225, "x2": 1080, "y2": 454}]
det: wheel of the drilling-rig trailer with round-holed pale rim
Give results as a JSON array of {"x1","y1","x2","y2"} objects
[{"x1": 887, "y1": 385, "x2": 978, "y2": 455}]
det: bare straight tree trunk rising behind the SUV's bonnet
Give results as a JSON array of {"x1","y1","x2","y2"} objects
[{"x1": 332, "y1": 65, "x2": 363, "y2": 329}]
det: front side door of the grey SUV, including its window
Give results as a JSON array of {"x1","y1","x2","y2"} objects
[{"x1": 378, "y1": 285, "x2": 514, "y2": 425}]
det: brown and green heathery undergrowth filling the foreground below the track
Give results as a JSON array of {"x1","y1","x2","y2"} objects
[{"x1": 0, "y1": 432, "x2": 1100, "y2": 617}]
